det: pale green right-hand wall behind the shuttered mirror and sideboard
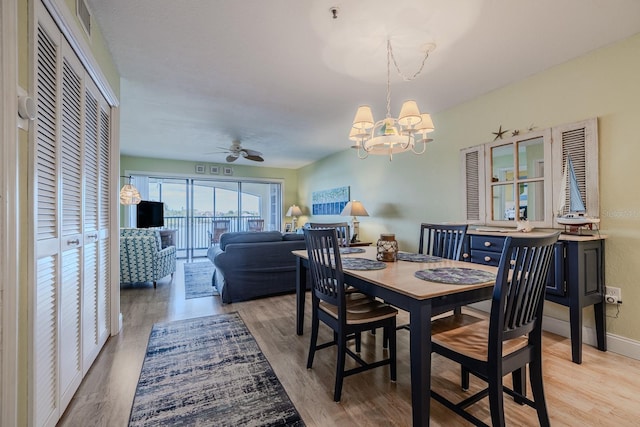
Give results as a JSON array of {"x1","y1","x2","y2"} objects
[{"x1": 298, "y1": 34, "x2": 640, "y2": 340}]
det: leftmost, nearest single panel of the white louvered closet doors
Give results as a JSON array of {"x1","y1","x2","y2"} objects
[{"x1": 29, "y1": 10, "x2": 62, "y2": 426}]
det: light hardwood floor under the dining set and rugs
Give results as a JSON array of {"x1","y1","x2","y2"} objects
[{"x1": 58, "y1": 263, "x2": 640, "y2": 427}]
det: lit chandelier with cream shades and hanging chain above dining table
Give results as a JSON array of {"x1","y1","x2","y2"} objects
[{"x1": 349, "y1": 40, "x2": 435, "y2": 161}]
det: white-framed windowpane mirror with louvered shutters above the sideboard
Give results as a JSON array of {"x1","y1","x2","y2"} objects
[{"x1": 460, "y1": 119, "x2": 599, "y2": 228}]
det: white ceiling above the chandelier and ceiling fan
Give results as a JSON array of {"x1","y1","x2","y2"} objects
[{"x1": 89, "y1": 0, "x2": 640, "y2": 168}]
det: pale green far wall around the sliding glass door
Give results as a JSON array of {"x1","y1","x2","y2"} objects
[{"x1": 119, "y1": 155, "x2": 298, "y2": 226}]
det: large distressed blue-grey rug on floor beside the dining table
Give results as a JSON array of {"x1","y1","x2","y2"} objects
[{"x1": 129, "y1": 313, "x2": 304, "y2": 427}]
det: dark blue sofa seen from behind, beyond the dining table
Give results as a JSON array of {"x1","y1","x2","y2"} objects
[{"x1": 207, "y1": 231, "x2": 306, "y2": 303}]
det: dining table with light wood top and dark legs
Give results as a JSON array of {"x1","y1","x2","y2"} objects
[{"x1": 293, "y1": 247, "x2": 497, "y2": 426}]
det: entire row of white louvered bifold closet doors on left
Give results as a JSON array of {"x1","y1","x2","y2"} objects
[{"x1": 28, "y1": 3, "x2": 111, "y2": 426}]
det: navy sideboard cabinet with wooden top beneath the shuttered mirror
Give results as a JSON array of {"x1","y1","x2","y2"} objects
[{"x1": 463, "y1": 230, "x2": 607, "y2": 363}]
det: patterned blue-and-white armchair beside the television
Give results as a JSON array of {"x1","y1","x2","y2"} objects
[{"x1": 120, "y1": 228, "x2": 176, "y2": 288}]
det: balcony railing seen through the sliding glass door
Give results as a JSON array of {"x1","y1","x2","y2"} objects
[{"x1": 164, "y1": 215, "x2": 267, "y2": 257}]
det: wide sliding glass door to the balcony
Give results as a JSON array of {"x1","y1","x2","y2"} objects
[{"x1": 132, "y1": 175, "x2": 282, "y2": 259}]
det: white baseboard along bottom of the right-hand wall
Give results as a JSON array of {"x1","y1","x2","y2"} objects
[{"x1": 464, "y1": 301, "x2": 640, "y2": 360}]
